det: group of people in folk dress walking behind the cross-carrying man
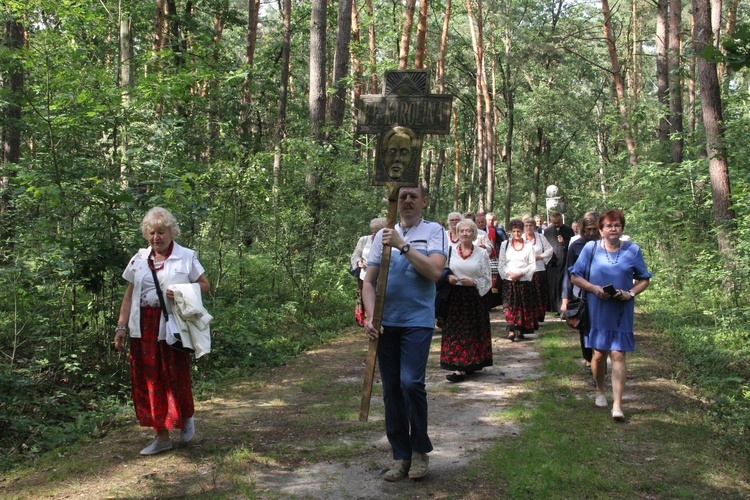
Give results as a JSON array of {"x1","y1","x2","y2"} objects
[{"x1": 351, "y1": 212, "x2": 575, "y2": 382}]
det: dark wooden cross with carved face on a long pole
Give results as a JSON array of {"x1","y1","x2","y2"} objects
[{"x1": 357, "y1": 69, "x2": 453, "y2": 422}]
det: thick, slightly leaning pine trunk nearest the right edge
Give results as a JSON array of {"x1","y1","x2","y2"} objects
[{"x1": 693, "y1": 0, "x2": 734, "y2": 255}]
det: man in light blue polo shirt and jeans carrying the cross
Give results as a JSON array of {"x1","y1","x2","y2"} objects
[{"x1": 362, "y1": 187, "x2": 448, "y2": 481}]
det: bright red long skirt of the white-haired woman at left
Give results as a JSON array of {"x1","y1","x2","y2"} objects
[{"x1": 130, "y1": 307, "x2": 194, "y2": 431}]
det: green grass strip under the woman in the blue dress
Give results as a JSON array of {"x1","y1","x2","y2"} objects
[{"x1": 470, "y1": 324, "x2": 750, "y2": 498}]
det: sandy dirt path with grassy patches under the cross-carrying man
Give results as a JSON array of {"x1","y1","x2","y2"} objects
[{"x1": 0, "y1": 311, "x2": 541, "y2": 499}]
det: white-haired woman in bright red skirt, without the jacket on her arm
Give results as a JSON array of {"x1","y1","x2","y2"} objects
[{"x1": 115, "y1": 207, "x2": 211, "y2": 455}]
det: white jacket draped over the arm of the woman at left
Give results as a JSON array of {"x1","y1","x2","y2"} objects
[{"x1": 167, "y1": 283, "x2": 214, "y2": 358}]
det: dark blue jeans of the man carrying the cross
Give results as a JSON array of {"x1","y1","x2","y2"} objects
[{"x1": 378, "y1": 326, "x2": 433, "y2": 460}]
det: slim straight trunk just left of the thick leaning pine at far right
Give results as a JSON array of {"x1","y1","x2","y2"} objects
[{"x1": 669, "y1": 0, "x2": 684, "y2": 163}]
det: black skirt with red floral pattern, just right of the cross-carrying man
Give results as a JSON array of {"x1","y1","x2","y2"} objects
[{"x1": 440, "y1": 286, "x2": 492, "y2": 371}]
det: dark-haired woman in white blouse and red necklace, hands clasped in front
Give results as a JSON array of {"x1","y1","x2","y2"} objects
[{"x1": 498, "y1": 219, "x2": 537, "y2": 342}]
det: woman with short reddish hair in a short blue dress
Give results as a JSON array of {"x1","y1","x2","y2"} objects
[{"x1": 570, "y1": 210, "x2": 653, "y2": 422}]
